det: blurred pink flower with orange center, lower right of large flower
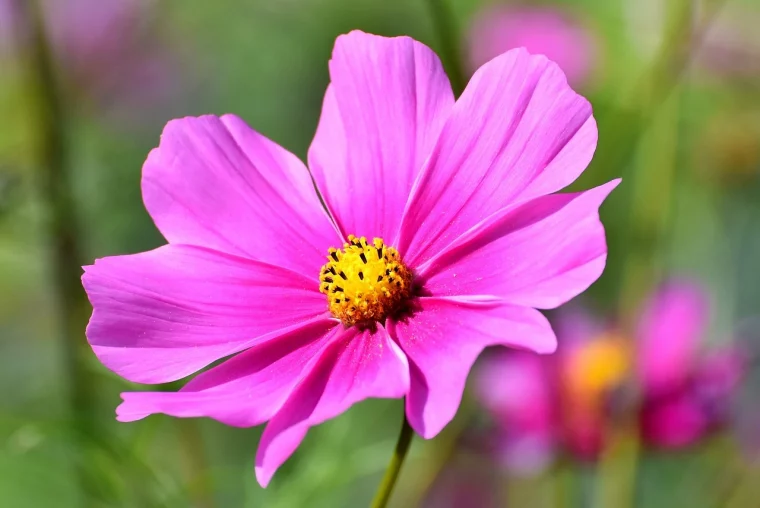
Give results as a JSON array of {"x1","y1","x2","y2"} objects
[{"x1": 476, "y1": 309, "x2": 629, "y2": 466}]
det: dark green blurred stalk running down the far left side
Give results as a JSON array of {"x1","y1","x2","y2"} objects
[{"x1": 15, "y1": 0, "x2": 96, "y2": 506}]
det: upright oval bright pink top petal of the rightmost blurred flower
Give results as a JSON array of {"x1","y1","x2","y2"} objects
[{"x1": 638, "y1": 281, "x2": 708, "y2": 393}]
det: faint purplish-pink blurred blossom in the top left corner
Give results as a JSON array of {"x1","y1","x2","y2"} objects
[{"x1": 0, "y1": 0, "x2": 179, "y2": 122}]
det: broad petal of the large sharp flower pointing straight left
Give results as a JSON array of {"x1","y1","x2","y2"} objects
[{"x1": 82, "y1": 245, "x2": 326, "y2": 383}]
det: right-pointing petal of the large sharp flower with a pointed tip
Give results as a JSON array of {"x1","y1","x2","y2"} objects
[{"x1": 418, "y1": 180, "x2": 620, "y2": 308}]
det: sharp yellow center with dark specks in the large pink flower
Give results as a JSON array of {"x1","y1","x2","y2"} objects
[{"x1": 319, "y1": 235, "x2": 412, "y2": 326}]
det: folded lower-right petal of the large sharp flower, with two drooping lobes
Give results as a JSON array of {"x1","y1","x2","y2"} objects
[{"x1": 388, "y1": 298, "x2": 556, "y2": 438}]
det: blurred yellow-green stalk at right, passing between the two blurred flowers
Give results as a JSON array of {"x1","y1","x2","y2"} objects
[{"x1": 594, "y1": 0, "x2": 708, "y2": 508}]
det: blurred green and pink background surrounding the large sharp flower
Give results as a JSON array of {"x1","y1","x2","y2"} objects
[{"x1": 0, "y1": 0, "x2": 760, "y2": 508}]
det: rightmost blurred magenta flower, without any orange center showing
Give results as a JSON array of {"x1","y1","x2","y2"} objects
[{"x1": 637, "y1": 281, "x2": 743, "y2": 448}]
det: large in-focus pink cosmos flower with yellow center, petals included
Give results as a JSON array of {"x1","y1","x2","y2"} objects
[{"x1": 83, "y1": 32, "x2": 618, "y2": 485}]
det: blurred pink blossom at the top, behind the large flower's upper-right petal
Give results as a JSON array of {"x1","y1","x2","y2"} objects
[{"x1": 468, "y1": 5, "x2": 597, "y2": 86}]
